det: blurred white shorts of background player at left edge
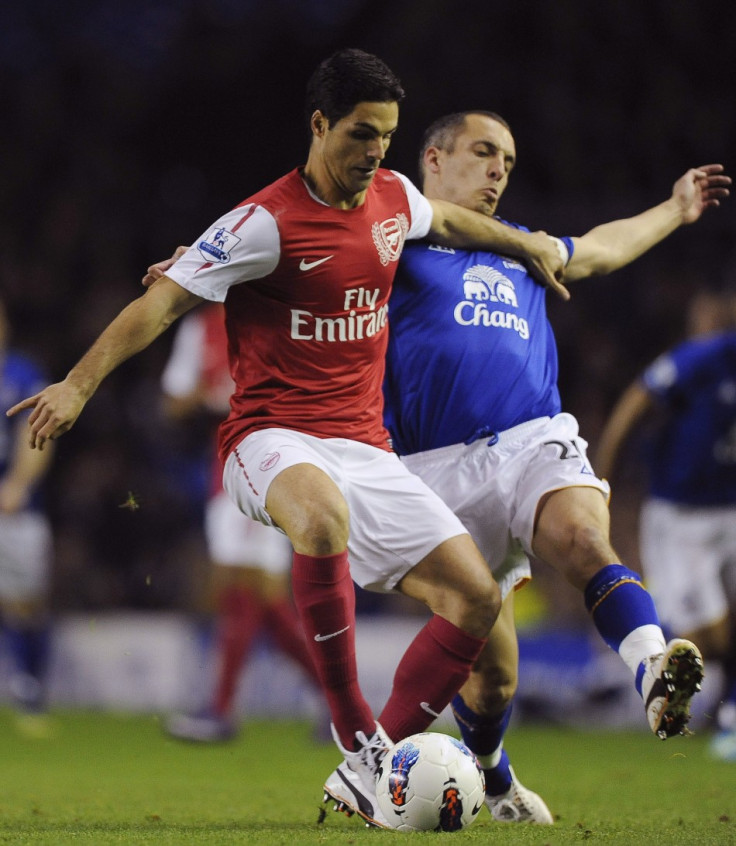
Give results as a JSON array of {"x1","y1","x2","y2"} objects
[{"x1": 0, "y1": 511, "x2": 52, "y2": 602}]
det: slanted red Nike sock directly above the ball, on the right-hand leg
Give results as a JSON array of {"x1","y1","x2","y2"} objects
[{"x1": 378, "y1": 615, "x2": 486, "y2": 741}]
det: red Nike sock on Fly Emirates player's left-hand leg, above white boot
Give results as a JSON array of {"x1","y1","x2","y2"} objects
[{"x1": 291, "y1": 550, "x2": 375, "y2": 749}]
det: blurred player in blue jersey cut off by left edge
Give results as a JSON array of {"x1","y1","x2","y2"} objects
[{"x1": 0, "y1": 302, "x2": 51, "y2": 734}]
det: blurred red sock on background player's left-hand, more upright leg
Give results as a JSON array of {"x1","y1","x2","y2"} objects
[{"x1": 213, "y1": 587, "x2": 266, "y2": 717}]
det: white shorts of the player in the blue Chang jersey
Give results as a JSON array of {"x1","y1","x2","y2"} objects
[{"x1": 402, "y1": 413, "x2": 610, "y2": 597}]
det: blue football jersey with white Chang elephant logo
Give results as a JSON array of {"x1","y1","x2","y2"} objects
[{"x1": 384, "y1": 222, "x2": 573, "y2": 455}]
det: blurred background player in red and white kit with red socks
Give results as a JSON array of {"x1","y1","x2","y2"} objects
[{"x1": 162, "y1": 303, "x2": 329, "y2": 742}]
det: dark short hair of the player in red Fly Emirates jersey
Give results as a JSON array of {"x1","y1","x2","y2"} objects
[{"x1": 306, "y1": 47, "x2": 404, "y2": 126}]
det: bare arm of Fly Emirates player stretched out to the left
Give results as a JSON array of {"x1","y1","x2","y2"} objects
[{"x1": 6, "y1": 276, "x2": 202, "y2": 449}]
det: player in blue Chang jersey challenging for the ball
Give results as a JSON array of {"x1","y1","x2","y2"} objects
[{"x1": 385, "y1": 111, "x2": 730, "y2": 823}]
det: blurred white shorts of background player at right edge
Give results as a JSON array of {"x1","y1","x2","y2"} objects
[{"x1": 639, "y1": 499, "x2": 736, "y2": 634}]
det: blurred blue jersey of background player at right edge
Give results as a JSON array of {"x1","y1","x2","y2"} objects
[{"x1": 642, "y1": 331, "x2": 736, "y2": 506}]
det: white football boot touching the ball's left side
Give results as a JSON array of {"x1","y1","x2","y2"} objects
[{"x1": 323, "y1": 723, "x2": 393, "y2": 828}]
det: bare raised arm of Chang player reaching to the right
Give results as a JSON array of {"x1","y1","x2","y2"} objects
[{"x1": 565, "y1": 164, "x2": 731, "y2": 282}]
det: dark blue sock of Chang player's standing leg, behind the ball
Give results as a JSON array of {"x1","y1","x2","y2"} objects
[{"x1": 452, "y1": 693, "x2": 511, "y2": 796}]
